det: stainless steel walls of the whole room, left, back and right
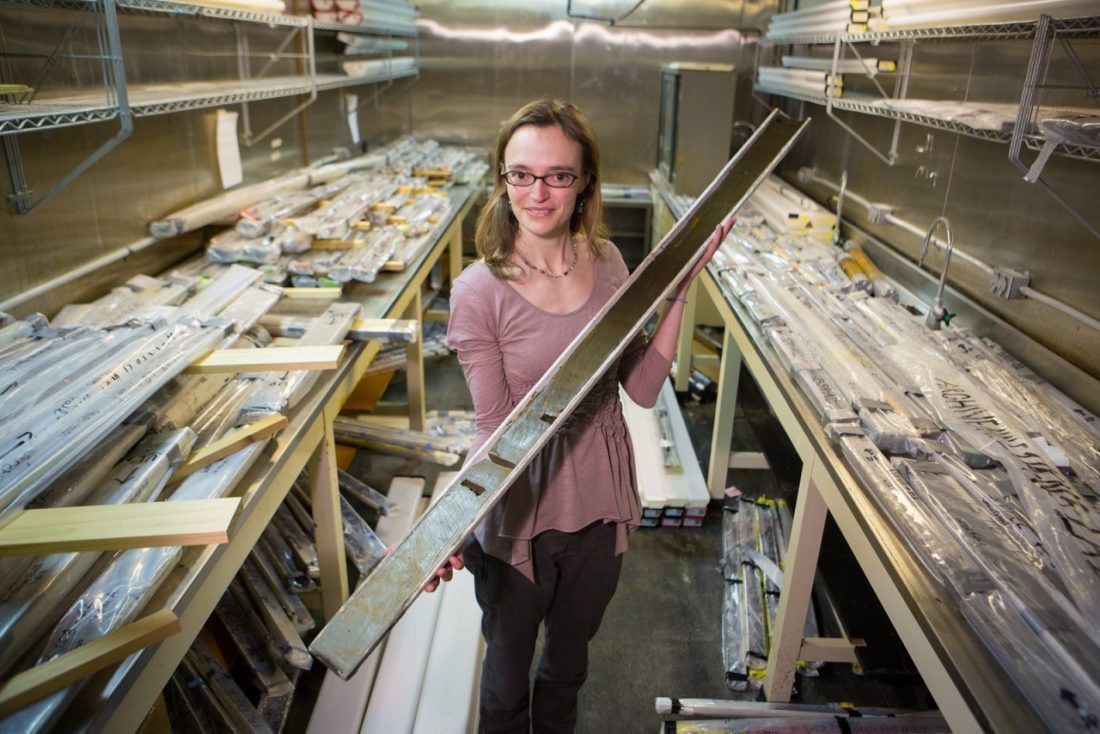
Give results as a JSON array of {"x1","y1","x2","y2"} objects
[{"x1": 0, "y1": 0, "x2": 1100, "y2": 398}]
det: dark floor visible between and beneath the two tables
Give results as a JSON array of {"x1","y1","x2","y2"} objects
[{"x1": 330, "y1": 334, "x2": 932, "y2": 734}]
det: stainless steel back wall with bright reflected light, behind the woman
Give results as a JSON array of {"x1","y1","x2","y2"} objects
[{"x1": 396, "y1": 0, "x2": 770, "y2": 184}]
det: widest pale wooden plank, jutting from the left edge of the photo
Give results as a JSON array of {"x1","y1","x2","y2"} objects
[{"x1": 0, "y1": 497, "x2": 241, "y2": 556}]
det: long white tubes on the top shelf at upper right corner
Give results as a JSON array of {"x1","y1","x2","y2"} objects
[{"x1": 882, "y1": 0, "x2": 1100, "y2": 31}]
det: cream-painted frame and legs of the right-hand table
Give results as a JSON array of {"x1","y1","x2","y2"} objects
[{"x1": 650, "y1": 179, "x2": 1078, "y2": 733}]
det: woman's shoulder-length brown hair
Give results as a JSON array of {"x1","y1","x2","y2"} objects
[{"x1": 475, "y1": 98, "x2": 607, "y2": 281}]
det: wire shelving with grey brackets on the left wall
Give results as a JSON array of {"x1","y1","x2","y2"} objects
[{"x1": 0, "y1": 0, "x2": 419, "y2": 213}]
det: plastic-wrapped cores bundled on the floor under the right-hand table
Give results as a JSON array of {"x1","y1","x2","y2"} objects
[{"x1": 721, "y1": 496, "x2": 824, "y2": 691}]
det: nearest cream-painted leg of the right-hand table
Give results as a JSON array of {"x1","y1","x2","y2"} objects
[{"x1": 763, "y1": 453, "x2": 828, "y2": 702}]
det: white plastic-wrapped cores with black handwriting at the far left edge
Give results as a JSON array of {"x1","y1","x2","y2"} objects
[{"x1": 0, "y1": 318, "x2": 226, "y2": 524}]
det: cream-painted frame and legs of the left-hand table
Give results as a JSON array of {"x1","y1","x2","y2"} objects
[{"x1": 26, "y1": 174, "x2": 481, "y2": 732}]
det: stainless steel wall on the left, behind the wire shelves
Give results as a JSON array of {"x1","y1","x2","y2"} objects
[{"x1": 0, "y1": 8, "x2": 365, "y2": 315}]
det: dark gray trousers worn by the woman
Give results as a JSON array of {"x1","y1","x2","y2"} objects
[{"x1": 464, "y1": 523, "x2": 623, "y2": 734}]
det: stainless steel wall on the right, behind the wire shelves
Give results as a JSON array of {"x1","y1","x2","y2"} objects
[{"x1": 781, "y1": 40, "x2": 1100, "y2": 379}]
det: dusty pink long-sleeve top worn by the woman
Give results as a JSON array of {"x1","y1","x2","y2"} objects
[{"x1": 447, "y1": 243, "x2": 671, "y2": 580}]
